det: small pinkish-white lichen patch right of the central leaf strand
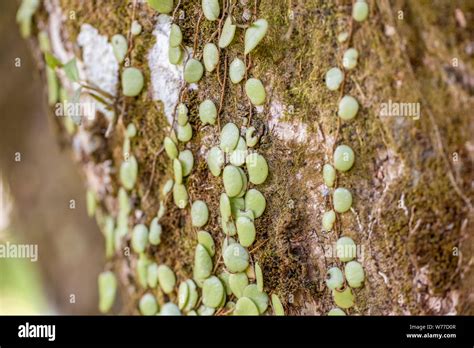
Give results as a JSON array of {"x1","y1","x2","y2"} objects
[{"x1": 268, "y1": 100, "x2": 308, "y2": 143}]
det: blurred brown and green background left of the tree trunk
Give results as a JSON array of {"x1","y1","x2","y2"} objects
[{"x1": 0, "y1": 0, "x2": 104, "y2": 314}]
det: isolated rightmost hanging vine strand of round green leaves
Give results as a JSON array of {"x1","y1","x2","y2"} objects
[{"x1": 322, "y1": 0, "x2": 368, "y2": 315}]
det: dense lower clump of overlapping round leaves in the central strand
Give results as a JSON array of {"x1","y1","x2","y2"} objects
[{"x1": 195, "y1": 123, "x2": 276, "y2": 315}]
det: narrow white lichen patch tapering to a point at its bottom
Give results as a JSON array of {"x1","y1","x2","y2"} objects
[{"x1": 148, "y1": 15, "x2": 183, "y2": 124}]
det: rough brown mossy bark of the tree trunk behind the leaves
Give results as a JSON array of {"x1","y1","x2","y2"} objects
[{"x1": 26, "y1": 0, "x2": 474, "y2": 315}]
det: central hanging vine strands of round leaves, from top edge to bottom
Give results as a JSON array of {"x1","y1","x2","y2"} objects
[{"x1": 183, "y1": 0, "x2": 283, "y2": 315}]
